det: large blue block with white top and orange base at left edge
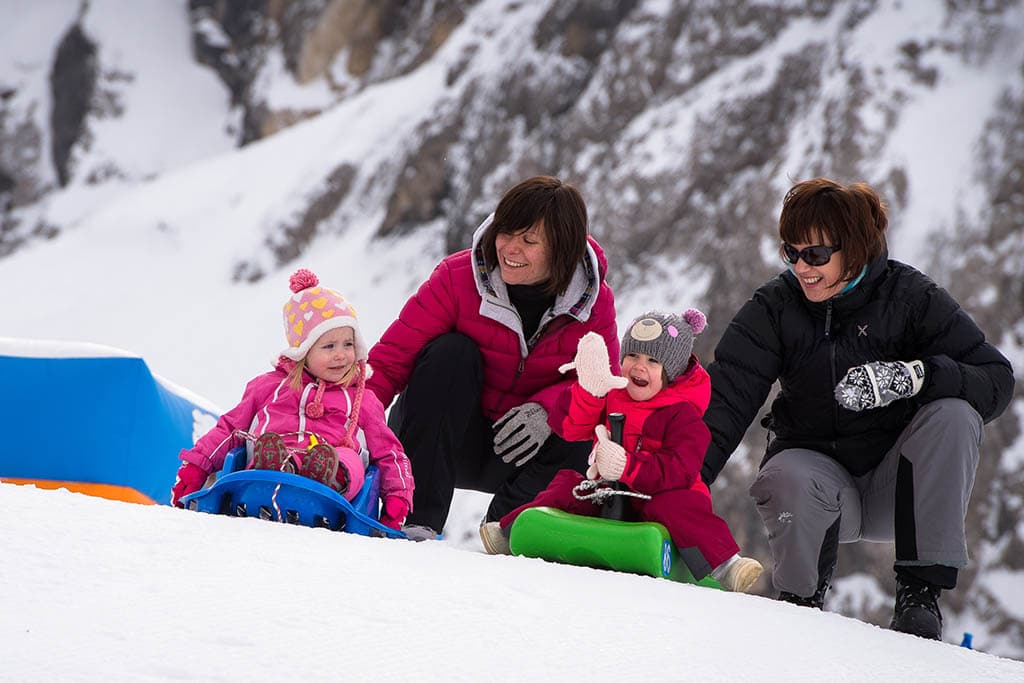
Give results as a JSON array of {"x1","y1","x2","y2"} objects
[{"x1": 0, "y1": 337, "x2": 217, "y2": 505}]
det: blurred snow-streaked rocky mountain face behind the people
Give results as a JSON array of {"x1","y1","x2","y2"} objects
[{"x1": 0, "y1": 0, "x2": 1024, "y2": 656}]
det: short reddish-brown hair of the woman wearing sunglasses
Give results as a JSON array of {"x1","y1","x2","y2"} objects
[{"x1": 778, "y1": 178, "x2": 889, "y2": 282}]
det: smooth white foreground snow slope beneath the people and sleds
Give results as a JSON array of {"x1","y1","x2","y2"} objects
[{"x1": 0, "y1": 484, "x2": 1024, "y2": 683}]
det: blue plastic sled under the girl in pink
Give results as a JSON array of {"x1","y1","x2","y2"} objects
[{"x1": 181, "y1": 446, "x2": 406, "y2": 539}]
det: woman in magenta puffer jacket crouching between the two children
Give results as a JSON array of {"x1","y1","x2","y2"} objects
[{"x1": 367, "y1": 176, "x2": 618, "y2": 539}]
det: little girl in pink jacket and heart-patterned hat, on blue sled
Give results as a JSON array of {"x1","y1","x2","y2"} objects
[{"x1": 171, "y1": 269, "x2": 414, "y2": 528}]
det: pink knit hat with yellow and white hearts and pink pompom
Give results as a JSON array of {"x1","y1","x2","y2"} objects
[{"x1": 281, "y1": 268, "x2": 367, "y2": 361}]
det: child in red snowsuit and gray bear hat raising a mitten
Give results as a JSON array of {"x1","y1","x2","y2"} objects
[{"x1": 480, "y1": 308, "x2": 763, "y2": 592}]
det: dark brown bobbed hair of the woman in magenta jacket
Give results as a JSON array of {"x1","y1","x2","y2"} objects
[{"x1": 480, "y1": 175, "x2": 587, "y2": 295}]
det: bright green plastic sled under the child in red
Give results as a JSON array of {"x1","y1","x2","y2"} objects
[{"x1": 509, "y1": 507, "x2": 722, "y2": 590}]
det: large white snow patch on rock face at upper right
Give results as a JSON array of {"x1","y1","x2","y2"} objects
[{"x1": 846, "y1": 0, "x2": 1024, "y2": 268}]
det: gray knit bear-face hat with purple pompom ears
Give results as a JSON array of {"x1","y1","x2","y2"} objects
[{"x1": 620, "y1": 308, "x2": 708, "y2": 383}]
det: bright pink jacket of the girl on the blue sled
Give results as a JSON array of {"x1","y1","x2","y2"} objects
[{"x1": 179, "y1": 360, "x2": 414, "y2": 507}]
